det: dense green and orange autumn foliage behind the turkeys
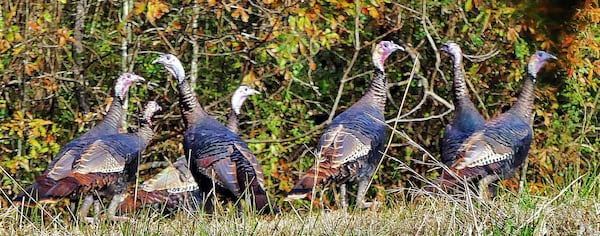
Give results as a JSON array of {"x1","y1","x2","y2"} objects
[{"x1": 0, "y1": 0, "x2": 600, "y2": 209}]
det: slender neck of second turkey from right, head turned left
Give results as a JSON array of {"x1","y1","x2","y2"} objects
[{"x1": 452, "y1": 59, "x2": 475, "y2": 116}]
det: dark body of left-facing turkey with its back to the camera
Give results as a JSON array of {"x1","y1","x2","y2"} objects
[{"x1": 183, "y1": 117, "x2": 268, "y2": 211}]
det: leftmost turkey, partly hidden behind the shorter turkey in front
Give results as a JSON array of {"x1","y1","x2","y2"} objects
[{"x1": 12, "y1": 73, "x2": 144, "y2": 212}]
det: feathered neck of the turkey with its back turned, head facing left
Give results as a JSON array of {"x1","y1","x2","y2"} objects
[{"x1": 177, "y1": 80, "x2": 208, "y2": 127}]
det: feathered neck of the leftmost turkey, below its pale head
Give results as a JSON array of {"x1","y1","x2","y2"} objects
[{"x1": 82, "y1": 96, "x2": 123, "y2": 137}]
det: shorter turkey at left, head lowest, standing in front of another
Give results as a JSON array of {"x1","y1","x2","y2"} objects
[{"x1": 34, "y1": 101, "x2": 160, "y2": 219}]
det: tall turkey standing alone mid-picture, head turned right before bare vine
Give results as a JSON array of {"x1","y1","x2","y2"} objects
[{"x1": 286, "y1": 41, "x2": 403, "y2": 209}]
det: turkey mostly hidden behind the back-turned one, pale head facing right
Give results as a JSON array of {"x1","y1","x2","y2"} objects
[{"x1": 120, "y1": 85, "x2": 259, "y2": 213}]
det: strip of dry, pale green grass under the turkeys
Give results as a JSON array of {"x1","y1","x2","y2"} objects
[{"x1": 0, "y1": 173, "x2": 600, "y2": 235}]
